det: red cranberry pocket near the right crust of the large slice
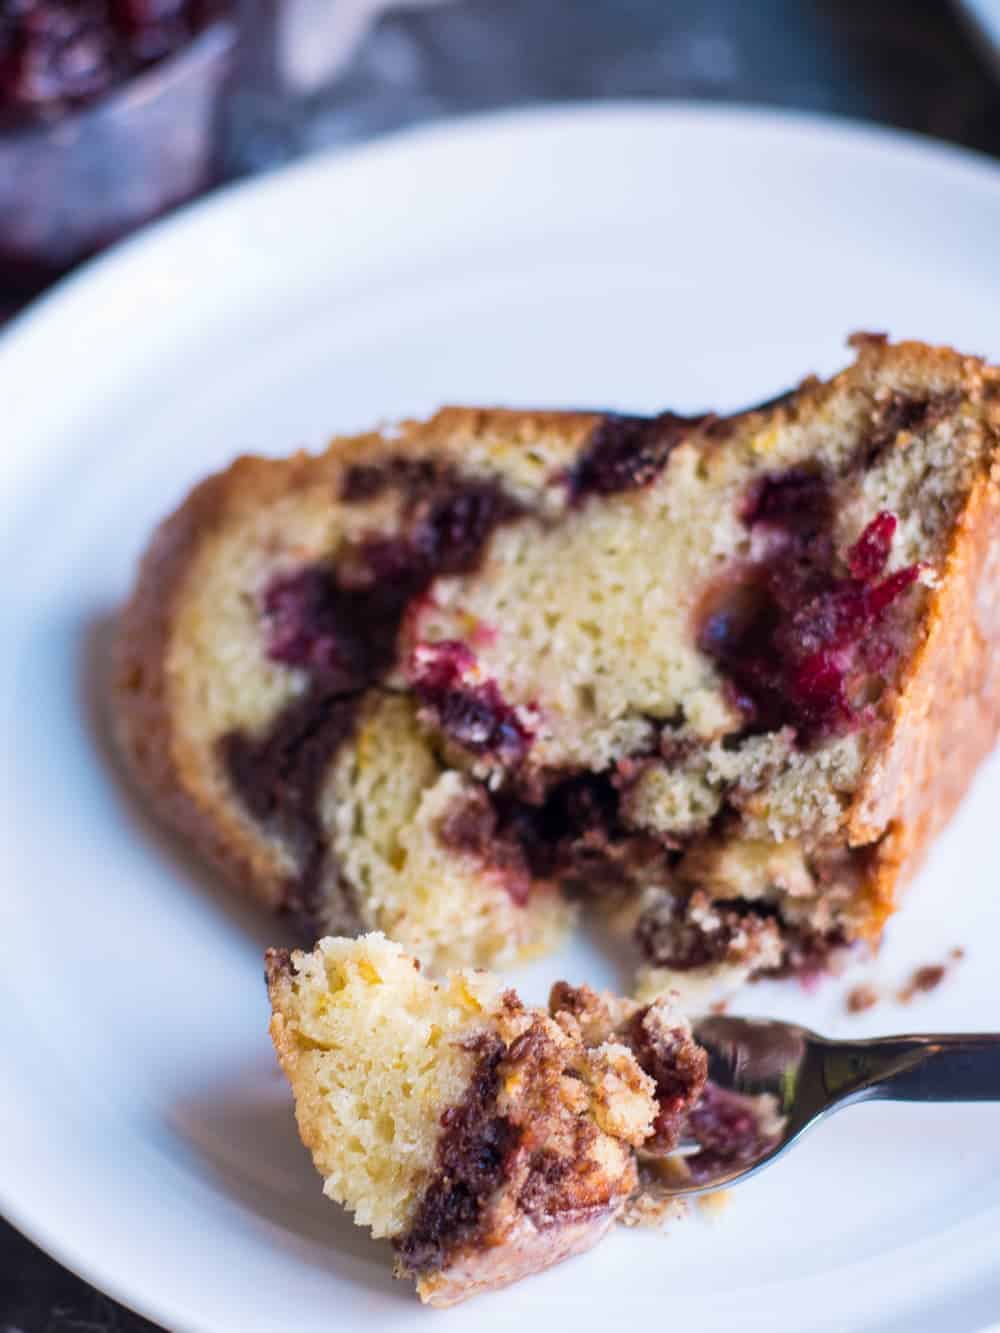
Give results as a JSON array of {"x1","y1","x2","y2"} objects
[{"x1": 699, "y1": 469, "x2": 920, "y2": 745}]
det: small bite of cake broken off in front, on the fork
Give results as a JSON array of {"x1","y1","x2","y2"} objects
[{"x1": 267, "y1": 934, "x2": 707, "y2": 1305}]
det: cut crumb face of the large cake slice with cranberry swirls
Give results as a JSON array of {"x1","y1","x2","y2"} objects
[{"x1": 186, "y1": 345, "x2": 992, "y2": 993}]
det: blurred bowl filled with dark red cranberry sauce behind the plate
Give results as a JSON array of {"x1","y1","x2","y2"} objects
[{"x1": 0, "y1": 0, "x2": 236, "y2": 289}]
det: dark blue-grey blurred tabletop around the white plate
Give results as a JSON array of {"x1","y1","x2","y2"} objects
[{"x1": 0, "y1": 0, "x2": 1000, "y2": 1333}]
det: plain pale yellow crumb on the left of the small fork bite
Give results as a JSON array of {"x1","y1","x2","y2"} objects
[{"x1": 272, "y1": 938, "x2": 500, "y2": 1237}]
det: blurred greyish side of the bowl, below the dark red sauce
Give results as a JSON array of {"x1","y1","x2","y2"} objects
[{"x1": 0, "y1": 19, "x2": 236, "y2": 287}]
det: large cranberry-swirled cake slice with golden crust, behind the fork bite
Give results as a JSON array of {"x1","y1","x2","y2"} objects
[{"x1": 116, "y1": 336, "x2": 1000, "y2": 990}]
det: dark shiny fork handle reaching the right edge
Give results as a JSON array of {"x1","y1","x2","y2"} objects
[{"x1": 824, "y1": 1033, "x2": 1000, "y2": 1101}]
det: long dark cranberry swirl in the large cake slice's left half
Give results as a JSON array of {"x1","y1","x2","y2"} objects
[{"x1": 219, "y1": 460, "x2": 529, "y2": 917}]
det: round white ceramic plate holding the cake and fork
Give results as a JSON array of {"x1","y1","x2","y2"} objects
[{"x1": 0, "y1": 107, "x2": 1000, "y2": 1333}]
